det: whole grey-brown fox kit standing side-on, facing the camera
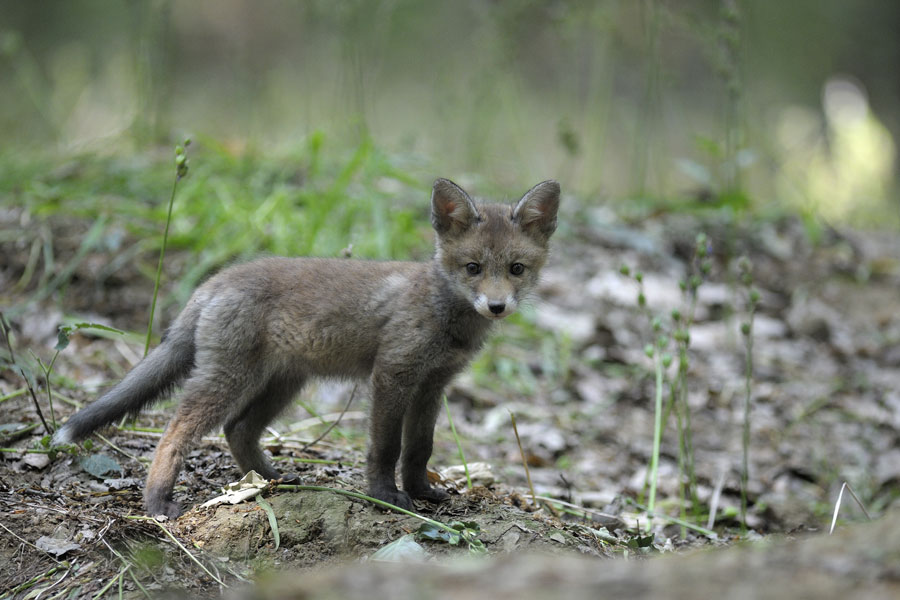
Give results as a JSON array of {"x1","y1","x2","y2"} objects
[{"x1": 53, "y1": 179, "x2": 559, "y2": 517}]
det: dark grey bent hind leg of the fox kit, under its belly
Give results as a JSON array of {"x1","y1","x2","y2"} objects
[{"x1": 225, "y1": 380, "x2": 303, "y2": 481}]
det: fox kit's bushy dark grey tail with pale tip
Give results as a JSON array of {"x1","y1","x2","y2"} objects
[{"x1": 53, "y1": 307, "x2": 199, "y2": 445}]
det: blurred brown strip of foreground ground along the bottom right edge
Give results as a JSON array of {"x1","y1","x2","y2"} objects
[{"x1": 232, "y1": 511, "x2": 900, "y2": 600}]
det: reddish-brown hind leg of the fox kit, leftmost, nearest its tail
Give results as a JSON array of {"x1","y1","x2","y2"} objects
[{"x1": 144, "y1": 368, "x2": 263, "y2": 518}]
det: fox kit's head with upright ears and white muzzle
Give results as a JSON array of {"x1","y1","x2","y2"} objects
[{"x1": 431, "y1": 179, "x2": 559, "y2": 320}]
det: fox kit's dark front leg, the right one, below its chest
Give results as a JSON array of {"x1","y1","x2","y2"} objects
[{"x1": 400, "y1": 381, "x2": 450, "y2": 502}]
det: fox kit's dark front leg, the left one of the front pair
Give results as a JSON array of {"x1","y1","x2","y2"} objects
[{"x1": 366, "y1": 369, "x2": 412, "y2": 509}]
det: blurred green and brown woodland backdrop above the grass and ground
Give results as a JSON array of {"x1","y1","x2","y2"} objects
[{"x1": 0, "y1": 0, "x2": 900, "y2": 230}]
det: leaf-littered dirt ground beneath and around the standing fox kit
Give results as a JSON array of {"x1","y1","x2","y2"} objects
[{"x1": 0, "y1": 204, "x2": 900, "y2": 598}]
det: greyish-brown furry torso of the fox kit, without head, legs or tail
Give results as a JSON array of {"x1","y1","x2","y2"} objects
[{"x1": 193, "y1": 257, "x2": 429, "y2": 376}]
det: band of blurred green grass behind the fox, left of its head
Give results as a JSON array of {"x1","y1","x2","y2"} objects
[{"x1": 0, "y1": 133, "x2": 432, "y2": 314}]
